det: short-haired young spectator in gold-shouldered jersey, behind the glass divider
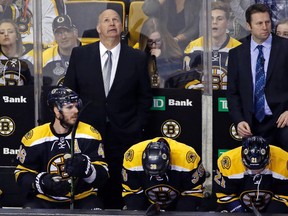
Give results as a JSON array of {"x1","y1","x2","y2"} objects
[{"x1": 183, "y1": 1, "x2": 241, "y2": 90}]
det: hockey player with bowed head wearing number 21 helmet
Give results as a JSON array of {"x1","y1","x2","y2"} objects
[{"x1": 214, "y1": 136, "x2": 288, "y2": 215}]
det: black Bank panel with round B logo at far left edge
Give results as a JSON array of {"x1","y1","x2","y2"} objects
[{"x1": 0, "y1": 86, "x2": 35, "y2": 167}]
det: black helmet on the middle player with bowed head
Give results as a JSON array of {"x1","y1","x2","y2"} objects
[{"x1": 142, "y1": 138, "x2": 170, "y2": 176}]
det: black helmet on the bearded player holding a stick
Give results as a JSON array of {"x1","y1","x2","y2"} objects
[{"x1": 47, "y1": 86, "x2": 82, "y2": 112}]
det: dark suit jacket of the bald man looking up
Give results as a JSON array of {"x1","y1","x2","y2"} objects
[{"x1": 64, "y1": 42, "x2": 152, "y2": 150}]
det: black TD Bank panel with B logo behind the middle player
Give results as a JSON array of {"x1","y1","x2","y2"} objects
[{"x1": 147, "y1": 89, "x2": 202, "y2": 153}]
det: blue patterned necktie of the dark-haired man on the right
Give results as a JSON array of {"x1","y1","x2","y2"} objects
[{"x1": 254, "y1": 45, "x2": 265, "y2": 122}]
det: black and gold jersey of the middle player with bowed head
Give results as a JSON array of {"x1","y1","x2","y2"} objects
[{"x1": 122, "y1": 137, "x2": 205, "y2": 210}]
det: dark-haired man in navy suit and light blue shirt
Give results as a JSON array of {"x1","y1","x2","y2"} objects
[{"x1": 227, "y1": 4, "x2": 288, "y2": 151}]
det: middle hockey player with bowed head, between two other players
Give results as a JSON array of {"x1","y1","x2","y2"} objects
[{"x1": 122, "y1": 137, "x2": 206, "y2": 211}]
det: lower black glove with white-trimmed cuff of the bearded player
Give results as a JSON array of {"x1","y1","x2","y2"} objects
[{"x1": 35, "y1": 172, "x2": 71, "y2": 196}]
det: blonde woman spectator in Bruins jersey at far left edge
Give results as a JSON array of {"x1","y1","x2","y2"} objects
[{"x1": 0, "y1": 19, "x2": 33, "y2": 86}]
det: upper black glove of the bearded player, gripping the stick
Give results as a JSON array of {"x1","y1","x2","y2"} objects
[{"x1": 64, "y1": 154, "x2": 93, "y2": 178}]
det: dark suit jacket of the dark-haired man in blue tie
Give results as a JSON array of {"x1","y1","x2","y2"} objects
[{"x1": 227, "y1": 35, "x2": 288, "y2": 127}]
